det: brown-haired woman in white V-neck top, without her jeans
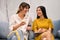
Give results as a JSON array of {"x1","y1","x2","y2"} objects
[{"x1": 9, "y1": 2, "x2": 31, "y2": 40}]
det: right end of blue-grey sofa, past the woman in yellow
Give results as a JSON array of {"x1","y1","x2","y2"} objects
[{"x1": 53, "y1": 20, "x2": 60, "y2": 40}]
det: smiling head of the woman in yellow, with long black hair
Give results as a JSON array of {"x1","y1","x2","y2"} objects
[{"x1": 36, "y1": 6, "x2": 48, "y2": 19}]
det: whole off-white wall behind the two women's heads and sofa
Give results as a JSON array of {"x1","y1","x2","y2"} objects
[{"x1": 0, "y1": 0, "x2": 60, "y2": 20}]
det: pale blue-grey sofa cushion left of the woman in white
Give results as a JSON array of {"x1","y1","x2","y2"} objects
[{"x1": 0, "y1": 21, "x2": 9, "y2": 38}]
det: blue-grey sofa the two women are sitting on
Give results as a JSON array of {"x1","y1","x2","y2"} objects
[{"x1": 0, "y1": 20, "x2": 60, "y2": 40}]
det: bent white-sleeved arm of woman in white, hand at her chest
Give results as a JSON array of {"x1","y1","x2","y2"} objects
[{"x1": 9, "y1": 16, "x2": 25, "y2": 31}]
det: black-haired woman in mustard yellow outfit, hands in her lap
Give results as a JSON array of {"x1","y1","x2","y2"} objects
[{"x1": 32, "y1": 6, "x2": 54, "y2": 40}]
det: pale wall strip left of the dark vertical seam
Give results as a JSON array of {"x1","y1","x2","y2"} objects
[{"x1": 0, "y1": 0, "x2": 8, "y2": 22}]
